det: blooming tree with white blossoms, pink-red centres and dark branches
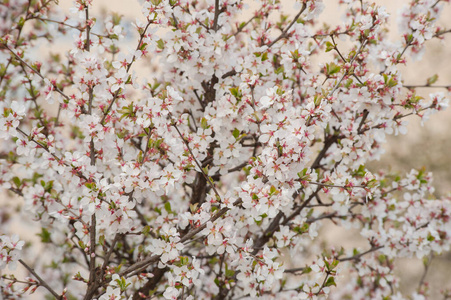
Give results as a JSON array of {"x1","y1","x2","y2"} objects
[{"x1": 0, "y1": 0, "x2": 451, "y2": 300}]
